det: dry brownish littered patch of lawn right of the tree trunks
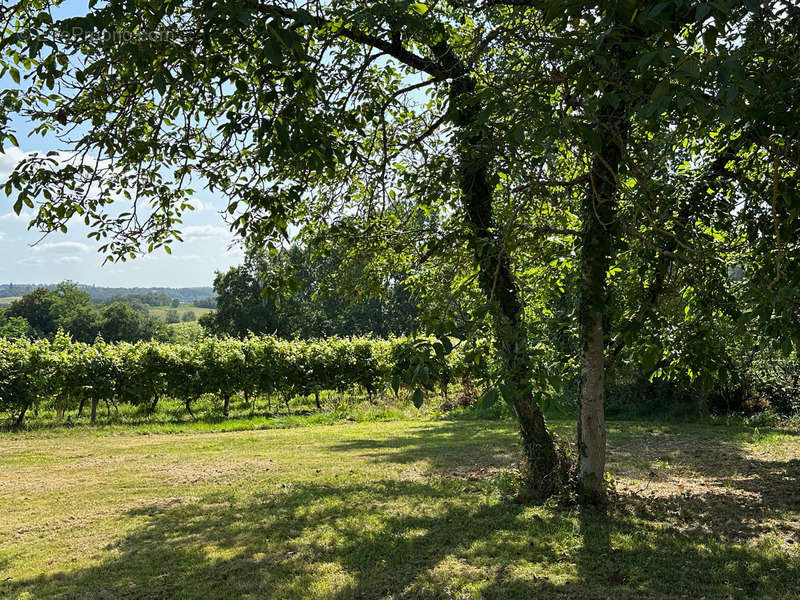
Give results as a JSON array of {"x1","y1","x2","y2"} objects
[{"x1": 609, "y1": 434, "x2": 800, "y2": 551}]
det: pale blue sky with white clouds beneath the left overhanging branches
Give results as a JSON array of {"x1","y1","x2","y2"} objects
[{"x1": 0, "y1": 0, "x2": 242, "y2": 287}]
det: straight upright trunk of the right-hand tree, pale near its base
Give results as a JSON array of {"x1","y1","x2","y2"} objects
[{"x1": 577, "y1": 106, "x2": 628, "y2": 501}]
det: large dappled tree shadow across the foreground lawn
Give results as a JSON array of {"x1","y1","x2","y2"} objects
[{"x1": 0, "y1": 480, "x2": 800, "y2": 599}]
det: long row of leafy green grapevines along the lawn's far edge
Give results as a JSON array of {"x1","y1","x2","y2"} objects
[{"x1": 0, "y1": 332, "x2": 476, "y2": 426}]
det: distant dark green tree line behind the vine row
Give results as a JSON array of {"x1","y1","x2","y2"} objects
[{"x1": 0, "y1": 246, "x2": 418, "y2": 343}]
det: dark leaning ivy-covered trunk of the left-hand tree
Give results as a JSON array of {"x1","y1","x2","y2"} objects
[{"x1": 451, "y1": 68, "x2": 562, "y2": 498}]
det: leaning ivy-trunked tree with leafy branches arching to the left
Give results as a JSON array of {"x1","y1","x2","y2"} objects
[{"x1": 0, "y1": 2, "x2": 560, "y2": 495}]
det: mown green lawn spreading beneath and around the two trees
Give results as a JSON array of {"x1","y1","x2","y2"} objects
[{"x1": 0, "y1": 420, "x2": 800, "y2": 600}]
